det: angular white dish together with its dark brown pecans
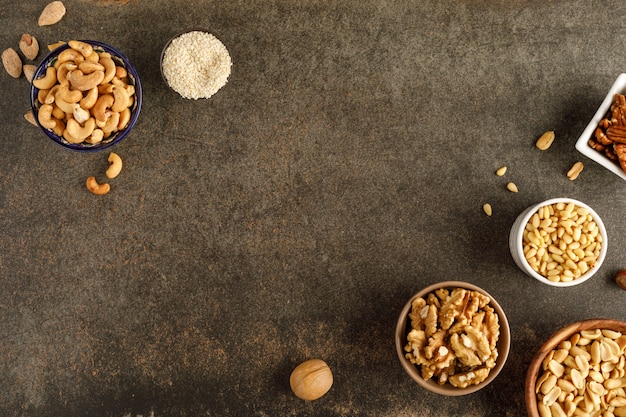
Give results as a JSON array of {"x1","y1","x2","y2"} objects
[{"x1": 576, "y1": 74, "x2": 626, "y2": 180}]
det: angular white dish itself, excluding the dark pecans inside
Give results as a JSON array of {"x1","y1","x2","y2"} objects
[{"x1": 576, "y1": 74, "x2": 626, "y2": 180}]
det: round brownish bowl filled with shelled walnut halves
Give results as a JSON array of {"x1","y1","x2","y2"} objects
[{"x1": 395, "y1": 281, "x2": 511, "y2": 396}]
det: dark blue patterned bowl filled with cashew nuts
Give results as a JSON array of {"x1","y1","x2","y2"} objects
[{"x1": 30, "y1": 40, "x2": 142, "y2": 151}]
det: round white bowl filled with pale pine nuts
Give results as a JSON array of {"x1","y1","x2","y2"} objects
[{"x1": 509, "y1": 198, "x2": 607, "y2": 287}]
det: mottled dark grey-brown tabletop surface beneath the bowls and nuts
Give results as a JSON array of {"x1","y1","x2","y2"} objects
[{"x1": 0, "y1": 0, "x2": 626, "y2": 417}]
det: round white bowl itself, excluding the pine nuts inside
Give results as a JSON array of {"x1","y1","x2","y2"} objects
[{"x1": 509, "y1": 198, "x2": 608, "y2": 287}]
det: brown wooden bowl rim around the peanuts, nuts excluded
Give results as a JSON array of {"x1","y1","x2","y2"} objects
[{"x1": 524, "y1": 319, "x2": 626, "y2": 417}]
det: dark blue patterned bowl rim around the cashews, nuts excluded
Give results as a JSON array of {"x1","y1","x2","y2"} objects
[{"x1": 30, "y1": 40, "x2": 142, "y2": 152}]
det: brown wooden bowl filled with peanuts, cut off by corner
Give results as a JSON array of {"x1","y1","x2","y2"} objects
[{"x1": 524, "y1": 319, "x2": 626, "y2": 417}]
